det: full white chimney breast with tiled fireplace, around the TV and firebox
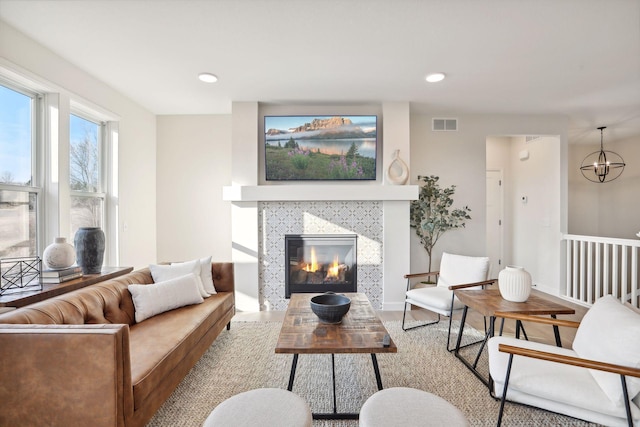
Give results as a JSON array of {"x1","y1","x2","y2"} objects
[{"x1": 223, "y1": 102, "x2": 418, "y2": 311}]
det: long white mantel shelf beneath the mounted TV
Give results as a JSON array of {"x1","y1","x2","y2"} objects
[{"x1": 222, "y1": 184, "x2": 419, "y2": 202}]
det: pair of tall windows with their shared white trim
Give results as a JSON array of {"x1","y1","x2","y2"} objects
[{"x1": 0, "y1": 73, "x2": 118, "y2": 263}]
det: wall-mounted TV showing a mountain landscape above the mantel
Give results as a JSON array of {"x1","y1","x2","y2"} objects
[{"x1": 264, "y1": 115, "x2": 378, "y2": 181}]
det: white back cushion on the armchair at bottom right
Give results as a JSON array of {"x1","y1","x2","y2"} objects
[{"x1": 573, "y1": 295, "x2": 640, "y2": 404}]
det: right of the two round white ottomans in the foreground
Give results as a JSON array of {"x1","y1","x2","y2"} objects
[{"x1": 360, "y1": 387, "x2": 469, "y2": 427}]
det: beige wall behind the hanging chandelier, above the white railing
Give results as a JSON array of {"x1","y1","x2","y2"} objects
[{"x1": 569, "y1": 135, "x2": 640, "y2": 239}]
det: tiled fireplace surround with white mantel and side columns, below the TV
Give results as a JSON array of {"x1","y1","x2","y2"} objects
[{"x1": 224, "y1": 184, "x2": 418, "y2": 311}]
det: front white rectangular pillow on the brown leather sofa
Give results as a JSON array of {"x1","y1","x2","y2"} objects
[{"x1": 128, "y1": 273, "x2": 204, "y2": 323}]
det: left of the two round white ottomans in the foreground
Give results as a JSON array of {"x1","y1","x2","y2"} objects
[{"x1": 203, "y1": 388, "x2": 313, "y2": 427}]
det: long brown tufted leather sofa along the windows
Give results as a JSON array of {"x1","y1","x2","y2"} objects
[{"x1": 0, "y1": 263, "x2": 235, "y2": 427}]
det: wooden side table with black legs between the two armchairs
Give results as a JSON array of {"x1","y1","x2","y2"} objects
[{"x1": 453, "y1": 289, "x2": 575, "y2": 389}]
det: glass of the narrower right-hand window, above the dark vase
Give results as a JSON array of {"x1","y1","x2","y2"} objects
[{"x1": 69, "y1": 114, "x2": 105, "y2": 236}]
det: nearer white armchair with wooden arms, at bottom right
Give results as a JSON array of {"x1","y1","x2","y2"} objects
[{"x1": 488, "y1": 295, "x2": 640, "y2": 426}]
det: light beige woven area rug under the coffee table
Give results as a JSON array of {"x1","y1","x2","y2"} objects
[{"x1": 148, "y1": 321, "x2": 594, "y2": 427}]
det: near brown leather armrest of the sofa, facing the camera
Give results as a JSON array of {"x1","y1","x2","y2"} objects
[{"x1": 0, "y1": 324, "x2": 133, "y2": 427}]
